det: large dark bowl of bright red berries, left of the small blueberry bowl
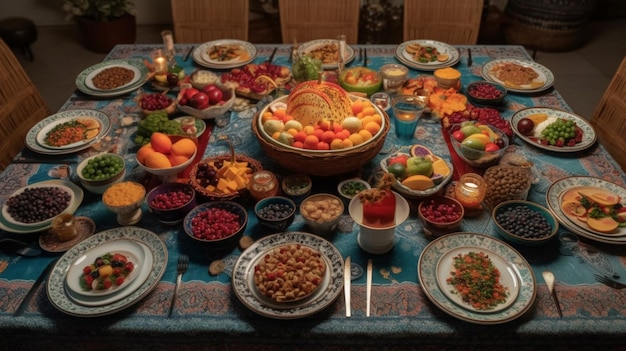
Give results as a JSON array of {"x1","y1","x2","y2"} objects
[{"x1": 183, "y1": 201, "x2": 248, "y2": 251}]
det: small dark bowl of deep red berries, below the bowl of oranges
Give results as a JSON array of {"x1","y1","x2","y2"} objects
[{"x1": 146, "y1": 183, "x2": 196, "y2": 224}]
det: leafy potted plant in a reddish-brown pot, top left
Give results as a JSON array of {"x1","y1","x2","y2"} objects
[{"x1": 63, "y1": 0, "x2": 136, "y2": 53}]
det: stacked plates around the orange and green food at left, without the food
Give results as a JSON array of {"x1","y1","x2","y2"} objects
[{"x1": 25, "y1": 109, "x2": 111, "y2": 155}]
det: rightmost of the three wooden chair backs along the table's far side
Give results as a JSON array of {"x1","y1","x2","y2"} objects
[{"x1": 404, "y1": 0, "x2": 484, "y2": 45}]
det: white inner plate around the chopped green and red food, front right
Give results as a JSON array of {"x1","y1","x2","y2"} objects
[{"x1": 437, "y1": 246, "x2": 520, "y2": 313}]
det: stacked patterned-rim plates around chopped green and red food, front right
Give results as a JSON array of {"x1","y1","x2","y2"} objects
[{"x1": 417, "y1": 233, "x2": 537, "y2": 324}]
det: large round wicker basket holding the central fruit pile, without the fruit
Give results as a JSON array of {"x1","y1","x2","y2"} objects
[{"x1": 252, "y1": 112, "x2": 391, "y2": 177}]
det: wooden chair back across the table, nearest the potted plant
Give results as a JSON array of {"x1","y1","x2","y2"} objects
[{"x1": 172, "y1": 0, "x2": 250, "y2": 43}]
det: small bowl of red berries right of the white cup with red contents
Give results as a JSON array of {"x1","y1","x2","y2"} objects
[{"x1": 417, "y1": 196, "x2": 465, "y2": 237}]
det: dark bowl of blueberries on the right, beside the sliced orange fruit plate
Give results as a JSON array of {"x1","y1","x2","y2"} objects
[{"x1": 491, "y1": 200, "x2": 559, "y2": 246}]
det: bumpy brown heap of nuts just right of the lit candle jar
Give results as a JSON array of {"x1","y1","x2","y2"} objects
[{"x1": 483, "y1": 165, "x2": 532, "y2": 208}]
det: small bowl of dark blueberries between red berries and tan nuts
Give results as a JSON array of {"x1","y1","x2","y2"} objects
[{"x1": 254, "y1": 196, "x2": 297, "y2": 232}]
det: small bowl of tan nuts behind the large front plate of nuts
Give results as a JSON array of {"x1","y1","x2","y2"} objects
[{"x1": 300, "y1": 193, "x2": 345, "y2": 235}]
